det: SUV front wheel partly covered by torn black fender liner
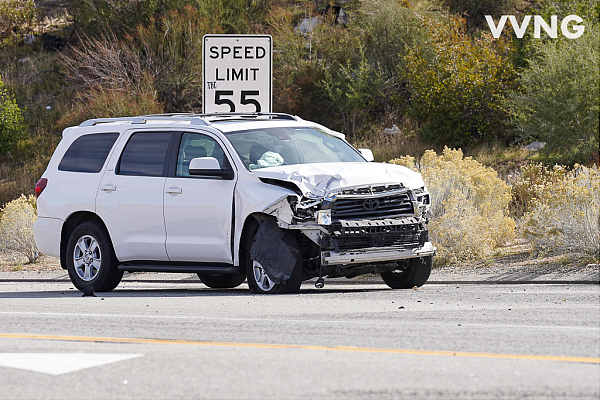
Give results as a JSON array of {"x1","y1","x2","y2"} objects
[{"x1": 244, "y1": 228, "x2": 303, "y2": 294}]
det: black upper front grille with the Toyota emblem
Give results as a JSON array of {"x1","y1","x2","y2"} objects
[{"x1": 332, "y1": 192, "x2": 415, "y2": 220}]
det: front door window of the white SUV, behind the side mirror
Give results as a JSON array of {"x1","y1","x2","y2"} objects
[{"x1": 175, "y1": 132, "x2": 230, "y2": 177}]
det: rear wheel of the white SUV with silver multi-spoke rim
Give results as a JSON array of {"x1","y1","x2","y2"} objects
[{"x1": 66, "y1": 221, "x2": 123, "y2": 292}]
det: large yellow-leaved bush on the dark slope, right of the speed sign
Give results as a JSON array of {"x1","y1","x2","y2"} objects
[{"x1": 406, "y1": 18, "x2": 515, "y2": 146}]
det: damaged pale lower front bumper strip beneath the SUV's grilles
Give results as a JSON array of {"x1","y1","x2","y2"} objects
[{"x1": 321, "y1": 242, "x2": 436, "y2": 266}]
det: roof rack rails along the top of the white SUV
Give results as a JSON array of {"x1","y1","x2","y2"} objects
[{"x1": 79, "y1": 113, "x2": 297, "y2": 127}]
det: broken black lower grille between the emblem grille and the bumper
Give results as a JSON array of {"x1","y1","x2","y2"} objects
[{"x1": 328, "y1": 218, "x2": 428, "y2": 252}]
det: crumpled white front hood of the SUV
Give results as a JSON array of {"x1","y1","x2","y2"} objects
[{"x1": 252, "y1": 163, "x2": 424, "y2": 198}]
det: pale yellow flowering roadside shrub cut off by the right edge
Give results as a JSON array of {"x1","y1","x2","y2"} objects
[{"x1": 520, "y1": 165, "x2": 599, "y2": 257}]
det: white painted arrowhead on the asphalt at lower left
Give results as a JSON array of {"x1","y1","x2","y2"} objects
[{"x1": 0, "y1": 353, "x2": 142, "y2": 376}]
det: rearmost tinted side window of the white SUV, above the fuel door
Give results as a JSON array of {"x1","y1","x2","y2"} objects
[{"x1": 58, "y1": 132, "x2": 119, "y2": 173}]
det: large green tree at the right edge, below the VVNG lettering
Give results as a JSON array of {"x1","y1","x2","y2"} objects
[{"x1": 509, "y1": 25, "x2": 600, "y2": 164}]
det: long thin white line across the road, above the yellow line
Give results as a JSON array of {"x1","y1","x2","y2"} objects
[{"x1": 0, "y1": 312, "x2": 599, "y2": 331}]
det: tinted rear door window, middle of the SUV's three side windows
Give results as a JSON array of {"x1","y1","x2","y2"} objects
[{"x1": 117, "y1": 132, "x2": 171, "y2": 177}]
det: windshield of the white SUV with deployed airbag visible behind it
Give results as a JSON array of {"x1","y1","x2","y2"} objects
[{"x1": 225, "y1": 127, "x2": 365, "y2": 170}]
